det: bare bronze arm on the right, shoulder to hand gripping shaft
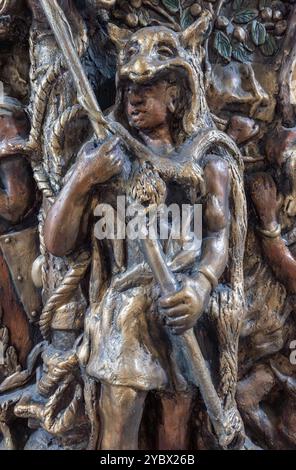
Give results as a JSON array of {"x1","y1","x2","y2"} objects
[{"x1": 159, "y1": 157, "x2": 230, "y2": 334}]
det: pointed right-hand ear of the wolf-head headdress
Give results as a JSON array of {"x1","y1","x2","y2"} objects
[{"x1": 180, "y1": 10, "x2": 213, "y2": 53}]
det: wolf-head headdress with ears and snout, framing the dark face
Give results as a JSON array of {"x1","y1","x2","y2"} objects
[{"x1": 109, "y1": 11, "x2": 212, "y2": 139}]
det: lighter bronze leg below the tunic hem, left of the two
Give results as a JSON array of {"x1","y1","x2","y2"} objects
[{"x1": 100, "y1": 384, "x2": 147, "y2": 450}]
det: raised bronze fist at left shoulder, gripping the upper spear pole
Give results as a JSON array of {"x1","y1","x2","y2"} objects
[{"x1": 78, "y1": 137, "x2": 124, "y2": 187}]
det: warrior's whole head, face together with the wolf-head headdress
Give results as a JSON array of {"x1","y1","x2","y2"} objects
[{"x1": 108, "y1": 11, "x2": 211, "y2": 142}]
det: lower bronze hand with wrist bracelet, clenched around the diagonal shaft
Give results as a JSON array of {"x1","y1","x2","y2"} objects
[{"x1": 158, "y1": 277, "x2": 209, "y2": 335}]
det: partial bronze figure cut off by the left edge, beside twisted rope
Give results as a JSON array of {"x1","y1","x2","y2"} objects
[{"x1": 0, "y1": 95, "x2": 41, "y2": 364}]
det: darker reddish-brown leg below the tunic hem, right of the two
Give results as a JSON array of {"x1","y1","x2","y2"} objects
[{"x1": 158, "y1": 393, "x2": 193, "y2": 450}]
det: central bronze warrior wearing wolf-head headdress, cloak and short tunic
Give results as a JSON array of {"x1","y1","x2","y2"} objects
[{"x1": 44, "y1": 13, "x2": 246, "y2": 449}]
